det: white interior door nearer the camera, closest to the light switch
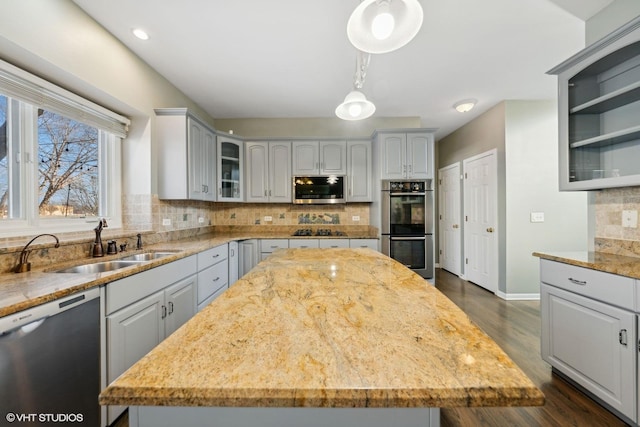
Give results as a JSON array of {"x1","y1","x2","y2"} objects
[{"x1": 462, "y1": 150, "x2": 498, "y2": 293}]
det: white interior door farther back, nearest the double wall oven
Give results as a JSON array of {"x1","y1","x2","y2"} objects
[{"x1": 438, "y1": 163, "x2": 462, "y2": 276}]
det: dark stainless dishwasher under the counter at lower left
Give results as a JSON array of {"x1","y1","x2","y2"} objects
[{"x1": 0, "y1": 288, "x2": 100, "y2": 426}]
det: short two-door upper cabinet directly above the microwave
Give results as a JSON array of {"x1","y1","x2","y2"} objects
[{"x1": 293, "y1": 141, "x2": 347, "y2": 175}]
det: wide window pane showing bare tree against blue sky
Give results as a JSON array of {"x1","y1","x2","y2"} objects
[{"x1": 38, "y1": 110, "x2": 98, "y2": 218}]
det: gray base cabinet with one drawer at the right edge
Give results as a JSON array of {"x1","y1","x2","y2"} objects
[{"x1": 540, "y1": 260, "x2": 638, "y2": 423}]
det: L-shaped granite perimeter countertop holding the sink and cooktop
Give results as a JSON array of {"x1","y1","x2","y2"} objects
[{"x1": 0, "y1": 232, "x2": 377, "y2": 317}]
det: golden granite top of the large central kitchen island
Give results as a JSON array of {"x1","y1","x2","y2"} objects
[{"x1": 100, "y1": 249, "x2": 544, "y2": 408}]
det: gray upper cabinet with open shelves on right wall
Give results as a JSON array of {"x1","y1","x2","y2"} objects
[{"x1": 549, "y1": 18, "x2": 640, "y2": 190}]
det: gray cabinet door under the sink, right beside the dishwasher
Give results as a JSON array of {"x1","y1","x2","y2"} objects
[{"x1": 107, "y1": 291, "x2": 165, "y2": 382}]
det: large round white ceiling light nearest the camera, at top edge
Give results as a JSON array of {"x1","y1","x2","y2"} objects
[{"x1": 347, "y1": 0, "x2": 423, "y2": 53}]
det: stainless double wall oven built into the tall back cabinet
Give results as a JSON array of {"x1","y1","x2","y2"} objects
[{"x1": 381, "y1": 180, "x2": 434, "y2": 278}]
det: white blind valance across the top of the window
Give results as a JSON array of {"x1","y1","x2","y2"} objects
[{"x1": 0, "y1": 61, "x2": 130, "y2": 138}]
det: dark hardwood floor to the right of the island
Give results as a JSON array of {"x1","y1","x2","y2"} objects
[{"x1": 436, "y1": 269, "x2": 626, "y2": 427}]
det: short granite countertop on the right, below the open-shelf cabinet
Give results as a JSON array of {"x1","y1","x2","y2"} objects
[{"x1": 533, "y1": 251, "x2": 640, "y2": 279}]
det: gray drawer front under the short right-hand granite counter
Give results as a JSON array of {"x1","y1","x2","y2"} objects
[{"x1": 540, "y1": 260, "x2": 635, "y2": 310}]
